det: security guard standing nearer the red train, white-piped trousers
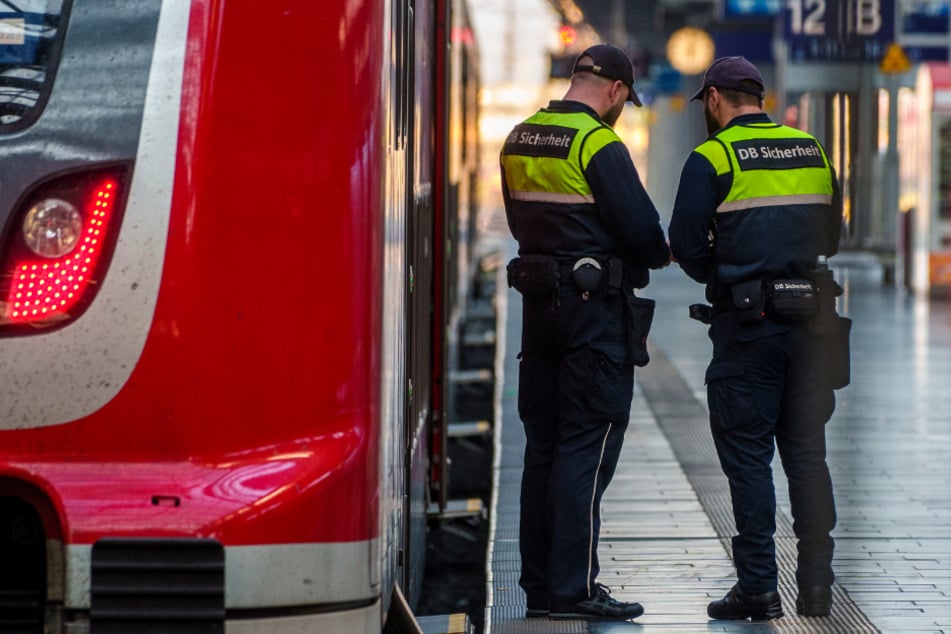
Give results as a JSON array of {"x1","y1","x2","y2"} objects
[{"x1": 500, "y1": 44, "x2": 670, "y2": 620}]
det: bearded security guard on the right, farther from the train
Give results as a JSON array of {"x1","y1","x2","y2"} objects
[{"x1": 669, "y1": 57, "x2": 851, "y2": 619}]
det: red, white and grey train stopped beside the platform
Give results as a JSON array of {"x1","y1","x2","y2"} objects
[{"x1": 0, "y1": 0, "x2": 479, "y2": 634}]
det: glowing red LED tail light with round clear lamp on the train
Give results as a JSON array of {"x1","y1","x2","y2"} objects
[{"x1": 0, "y1": 169, "x2": 124, "y2": 330}]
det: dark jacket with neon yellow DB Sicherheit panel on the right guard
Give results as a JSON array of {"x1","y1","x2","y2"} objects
[{"x1": 669, "y1": 113, "x2": 842, "y2": 286}]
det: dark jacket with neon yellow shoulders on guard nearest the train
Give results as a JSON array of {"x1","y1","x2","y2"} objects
[{"x1": 500, "y1": 101, "x2": 669, "y2": 288}]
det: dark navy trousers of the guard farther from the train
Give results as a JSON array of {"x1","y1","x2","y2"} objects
[{"x1": 706, "y1": 314, "x2": 836, "y2": 594}]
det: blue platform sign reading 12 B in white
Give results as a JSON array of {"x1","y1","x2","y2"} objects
[{"x1": 783, "y1": 0, "x2": 895, "y2": 62}]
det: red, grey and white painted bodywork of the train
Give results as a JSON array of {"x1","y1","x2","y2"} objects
[{"x1": 0, "y1": 0, "x2": 468, "y2": 632}]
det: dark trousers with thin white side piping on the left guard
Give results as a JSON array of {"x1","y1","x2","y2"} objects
[{"x1": 519, "y1": 292, "x2": 634, "y2": 609}]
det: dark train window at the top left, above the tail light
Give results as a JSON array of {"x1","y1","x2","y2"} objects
[{"x1": 0, "y1": 0, "x2": 70, "y2": 132}]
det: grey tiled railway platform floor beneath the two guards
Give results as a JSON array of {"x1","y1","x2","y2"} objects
[{"x1": 484, "y1": 240, "x2": 951, "y2": 634}]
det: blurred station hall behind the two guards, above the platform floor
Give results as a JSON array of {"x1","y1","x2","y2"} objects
[{"x1": 472, "y1": 0, "x2": 951, "y2": 296}]
